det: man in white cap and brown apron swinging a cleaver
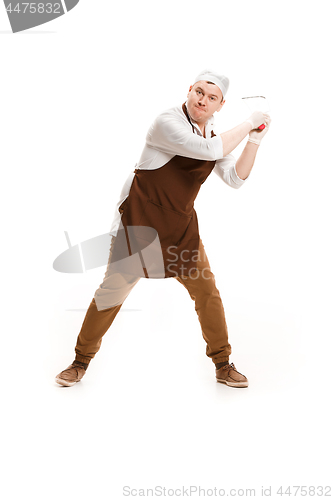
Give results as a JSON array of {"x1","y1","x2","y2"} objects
[{"x1": 56, "y1": 71, "x2": 270, "y2": 387}]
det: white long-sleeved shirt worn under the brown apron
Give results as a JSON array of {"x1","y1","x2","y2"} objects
[{"x1": 109, "y1": 105, "x2": 245, "y2": 236}]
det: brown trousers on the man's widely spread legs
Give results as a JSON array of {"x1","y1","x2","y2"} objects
[{"x1": 75, "y1": 238, "x2": 231, "y2": 363}]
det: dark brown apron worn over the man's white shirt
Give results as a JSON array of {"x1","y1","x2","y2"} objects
[{"x1": 115, "y1": 104, "x2": 215, "y2": 278}]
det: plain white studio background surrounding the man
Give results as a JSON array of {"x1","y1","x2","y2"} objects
[{"x1": 0, "y1": 0, "x2": 333, "y2": 500}]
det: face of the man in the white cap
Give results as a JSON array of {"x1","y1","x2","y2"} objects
[{"x1": 187, "y1": 80, "x2": 225, "y2": 124}]
